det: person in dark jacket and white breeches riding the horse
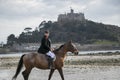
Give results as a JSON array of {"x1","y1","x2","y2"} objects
[{"x1": 38, "y1": 30, "x2": 56, "y2": 69}]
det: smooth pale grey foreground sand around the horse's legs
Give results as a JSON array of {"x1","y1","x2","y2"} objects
[{"x1": 0, "y1": 65, "x2": 120, "y2": 80}]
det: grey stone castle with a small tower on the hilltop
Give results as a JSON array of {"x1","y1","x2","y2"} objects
[{"x1": 58, "y1": 9, "x2": 85, "y2": 22}]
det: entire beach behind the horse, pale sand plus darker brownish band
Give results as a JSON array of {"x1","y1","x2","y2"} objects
[{"x1": 0, "y1": 55, "x2": 120, "y2": 80}]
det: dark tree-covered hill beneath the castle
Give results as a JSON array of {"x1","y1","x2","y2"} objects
[{"x1": 7, "y1": 20, "x2": 120, "y2": 45}]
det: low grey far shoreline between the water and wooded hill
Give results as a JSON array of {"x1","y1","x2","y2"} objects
[{"x1": 0, "y1": 43, "x2": 120, "y2": 54}]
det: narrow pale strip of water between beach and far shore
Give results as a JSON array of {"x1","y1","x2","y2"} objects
[{"x1": 0, "y1": 50, "x2": 120, "y2": 57}]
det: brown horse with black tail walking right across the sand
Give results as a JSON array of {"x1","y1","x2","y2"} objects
[{"x1": 12, "y1": 41, "x2": 78, "y2": 80}]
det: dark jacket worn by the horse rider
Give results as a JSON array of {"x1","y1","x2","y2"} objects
[{"x1": 38, "y1": 36, "x2": 51, "y2": 54}]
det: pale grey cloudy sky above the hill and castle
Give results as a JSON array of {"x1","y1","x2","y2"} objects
[{"x1": 0, "y1": 0, "x2": 120, "y2": 43}]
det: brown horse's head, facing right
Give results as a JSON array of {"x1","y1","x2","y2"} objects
[{"x1": 66, "y1": 41, "x2": 78, "y2": 55}]
